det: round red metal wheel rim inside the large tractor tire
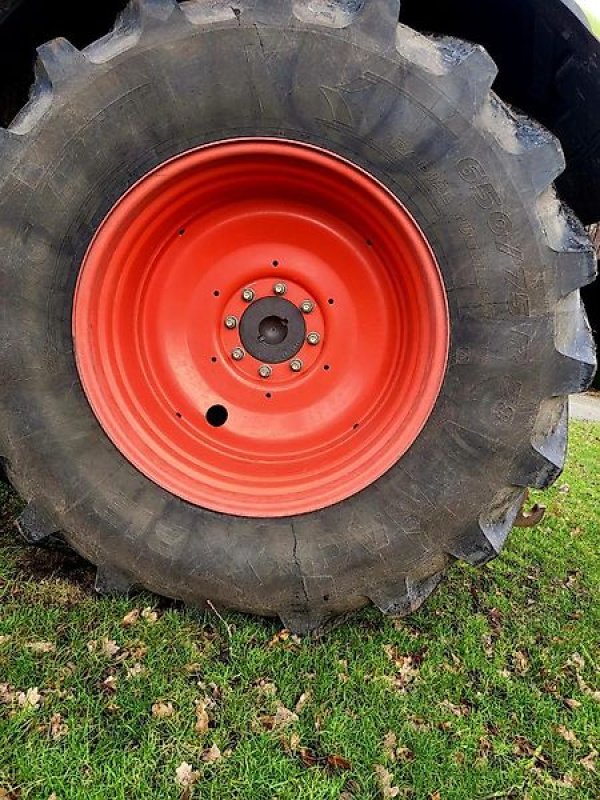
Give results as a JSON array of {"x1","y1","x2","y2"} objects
[{"x1": 73, "y1": 138, "x2": 449, "y2": 517}]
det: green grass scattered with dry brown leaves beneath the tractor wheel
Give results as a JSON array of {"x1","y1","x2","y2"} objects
[{"x1": 0, "y1": 423, "x2": 600, "y2": 800}]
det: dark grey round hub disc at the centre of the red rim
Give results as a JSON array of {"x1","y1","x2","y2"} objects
[{"x1": 240, "y1": 297, "x2": 306, "y2": 364}]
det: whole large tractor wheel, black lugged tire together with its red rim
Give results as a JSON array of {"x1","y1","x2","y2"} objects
[{"x1": 0, "y1": 0, "x2": 596, "y2": 634}]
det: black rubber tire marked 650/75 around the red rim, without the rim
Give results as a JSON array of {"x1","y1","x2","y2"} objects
[{"x1": 0, "y1": 0, "x2": 596, "y2": 633}]
